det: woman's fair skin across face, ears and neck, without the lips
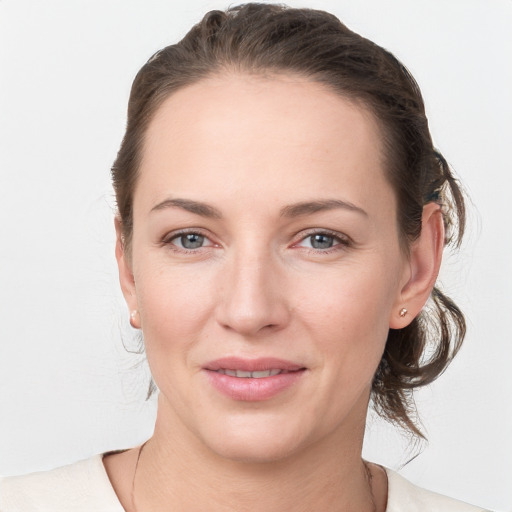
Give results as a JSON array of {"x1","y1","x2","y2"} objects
[{"x1": 104, "y1": 74, "x2": 444, "y2": 512}]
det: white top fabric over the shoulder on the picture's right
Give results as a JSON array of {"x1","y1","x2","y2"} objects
[{"x1": 386, "y1": 469, "x2": 489, "y2": 512}]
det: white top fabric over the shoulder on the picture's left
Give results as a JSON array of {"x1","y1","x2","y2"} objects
[{"x1": 0, "y1": 455, "x2": 123, "y2": 512}]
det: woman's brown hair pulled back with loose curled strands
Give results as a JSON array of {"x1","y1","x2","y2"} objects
[{"x1": 112, "y1": 3, "x2": 466, "y2": 437}]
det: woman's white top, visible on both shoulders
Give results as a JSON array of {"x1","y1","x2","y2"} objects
[{"x1": 0, "y1": 454, "x2": 489, "y2": 512}]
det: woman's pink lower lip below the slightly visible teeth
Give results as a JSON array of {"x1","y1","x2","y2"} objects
[{"x1": 205, "y1": 370, "x2": 306, "y2": 402}]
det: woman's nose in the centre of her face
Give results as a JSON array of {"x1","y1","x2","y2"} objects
[{"x1": 217, "y1": 248, "x2": 291, "y2": 337}]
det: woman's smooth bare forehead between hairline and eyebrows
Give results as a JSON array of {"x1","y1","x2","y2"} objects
[{"x1": 135, "y1": 74, "x2": 390, "y2": 214}]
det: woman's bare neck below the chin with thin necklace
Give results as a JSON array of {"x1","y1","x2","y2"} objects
[{"x1": 133, "y1": 394, "x2": 376, "y2": 512}]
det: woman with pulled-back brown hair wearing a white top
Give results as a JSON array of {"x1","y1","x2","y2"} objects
[{"x1": 0, "y1": 4, "x2": 494, "y2": 512}]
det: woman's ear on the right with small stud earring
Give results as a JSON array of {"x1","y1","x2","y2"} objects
[{"x1": 389, "y1": 203, "x2": 445, "y2": 329}]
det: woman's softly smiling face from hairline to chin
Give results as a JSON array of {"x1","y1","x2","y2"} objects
[{"x1": 120, "y1": 75, "x2": 409, "y2": 460}]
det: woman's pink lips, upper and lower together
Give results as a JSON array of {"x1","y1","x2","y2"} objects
[{"x1": 203, "y1": 357, "x2": 307, "y2": 402}]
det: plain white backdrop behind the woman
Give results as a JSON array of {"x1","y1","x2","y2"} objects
[{"x1": 0, "y1": 0, "x2": 512, "y2": 511}]
